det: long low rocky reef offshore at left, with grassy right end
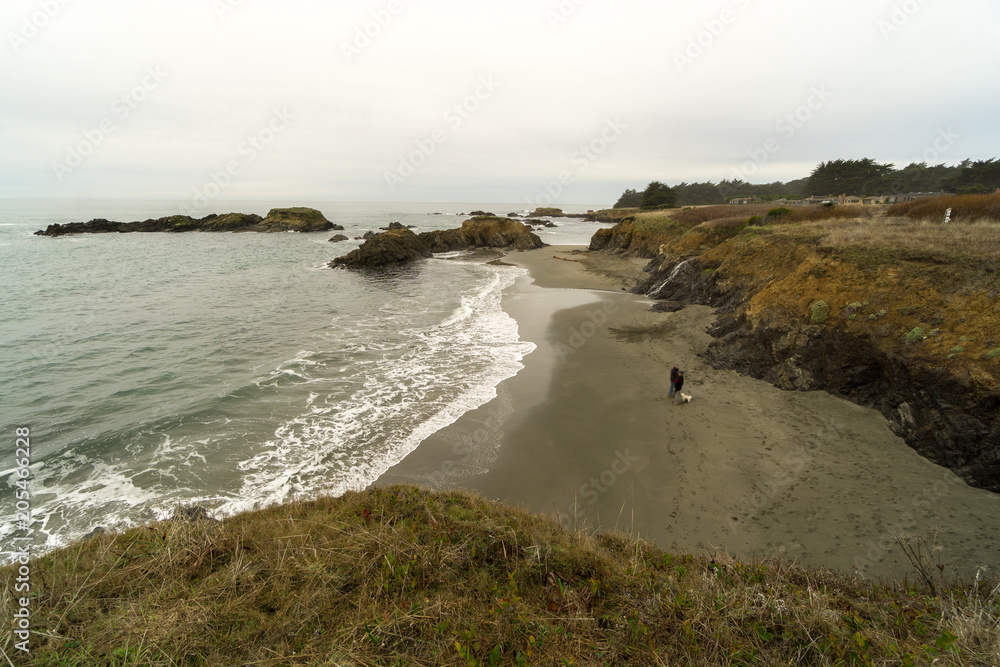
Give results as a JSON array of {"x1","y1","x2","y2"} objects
[{"x1": 35, "y1": 207, "x2": 343, "y2": 236}]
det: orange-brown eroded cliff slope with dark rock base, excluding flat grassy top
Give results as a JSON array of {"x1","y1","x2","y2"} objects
[{"x1": 635, "y1": 235, "x2": 1000, "y2": 492}]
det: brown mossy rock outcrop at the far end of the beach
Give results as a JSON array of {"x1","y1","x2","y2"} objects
[{"x1": 330, "y1": 215, "x2": 545, "y2": 269}]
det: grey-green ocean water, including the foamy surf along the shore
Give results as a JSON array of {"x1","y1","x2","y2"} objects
[{"x1": 0, "y1": 200, "x2": 598, "y2": 560}]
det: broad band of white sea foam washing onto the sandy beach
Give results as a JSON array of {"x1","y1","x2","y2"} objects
[{"x1": 221, "y1": 267, "x2": 535, "y2": 513}]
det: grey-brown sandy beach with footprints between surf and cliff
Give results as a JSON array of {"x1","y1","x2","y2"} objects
[{"x1": 377, "y1": 247, "x2": 1000, "y2": 576}]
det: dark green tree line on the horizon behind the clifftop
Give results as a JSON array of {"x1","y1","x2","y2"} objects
[{"x1": 614, "y1": 158, "x2": 1000, "y2": 209}]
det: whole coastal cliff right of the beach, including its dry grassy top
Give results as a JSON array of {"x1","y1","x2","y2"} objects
[{"x1": 591, "y1": 201, "x2": 1000, "y2": 492}]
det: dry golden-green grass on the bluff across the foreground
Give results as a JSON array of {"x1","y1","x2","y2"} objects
[{"x1": 0, "y1": 487, "x2": 1000, "y2": 667}]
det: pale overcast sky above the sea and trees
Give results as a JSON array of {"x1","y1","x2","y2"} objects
[{"x1": 0, "y1": 0, "x2": 1000, "y2": 205}]
